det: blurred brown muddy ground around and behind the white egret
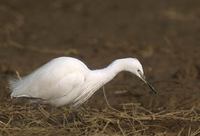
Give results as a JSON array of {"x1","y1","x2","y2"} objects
[{"x1": 0, "y1": 0, "x2": 200, "y2": 135}]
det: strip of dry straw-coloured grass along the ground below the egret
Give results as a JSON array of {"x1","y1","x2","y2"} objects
[{"x1": 0, "y1": 103, "x2": 200, "y2": 136}]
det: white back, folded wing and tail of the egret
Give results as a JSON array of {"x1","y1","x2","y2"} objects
[{"x1": 10, "y1": 57, "x2": 89, "y2": 99}]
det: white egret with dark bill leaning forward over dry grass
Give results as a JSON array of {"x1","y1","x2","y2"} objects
[{"x1": 9, "y1": 57, "x2": 156, "y2": 107}]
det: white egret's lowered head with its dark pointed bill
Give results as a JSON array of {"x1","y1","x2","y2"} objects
[{"x1": 122, "y1": 58, "x2": 156, "y2": 93}]
